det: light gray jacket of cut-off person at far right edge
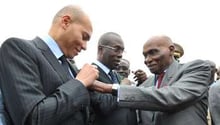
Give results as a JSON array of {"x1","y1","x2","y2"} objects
[{"x1": 209, "y1": 81, "x2": 220, "y2": 125}]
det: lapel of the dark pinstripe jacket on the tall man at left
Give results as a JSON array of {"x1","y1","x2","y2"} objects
[{"x1": 33, "y1": 37, "x2": 68, "y2": 82}]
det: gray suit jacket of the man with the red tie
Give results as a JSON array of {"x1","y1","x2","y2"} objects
[{"x1": 119, "y1": 60, "x2": 211, "y2": 125}]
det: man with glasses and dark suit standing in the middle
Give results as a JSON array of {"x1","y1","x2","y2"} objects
[{"x1": 92, "y1": 32, "x2": 137, "y2": 125}]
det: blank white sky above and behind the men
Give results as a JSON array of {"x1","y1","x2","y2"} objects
[{"x1": 0, "y1": 0, "x2": 220, "y2": 77}]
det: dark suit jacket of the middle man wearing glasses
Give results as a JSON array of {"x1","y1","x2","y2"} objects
[{"x1": 91, "y1": 66, "x2": 137, "y2": 125}]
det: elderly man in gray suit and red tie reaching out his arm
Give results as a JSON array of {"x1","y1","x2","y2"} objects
[{"x1": 91, "y1": 36, "x2": 211, "y2": 125}]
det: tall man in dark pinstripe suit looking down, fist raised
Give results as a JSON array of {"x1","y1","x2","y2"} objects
[{"x1": 0, "y1": 5, "x2": 98, "y2": 125}]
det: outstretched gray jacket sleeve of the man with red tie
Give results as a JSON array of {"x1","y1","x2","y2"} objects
[{"x1": 119, "y1": 60, "x2": 211, "y2": 111}]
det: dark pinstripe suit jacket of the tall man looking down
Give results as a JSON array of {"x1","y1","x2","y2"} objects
[{"x1": 0, "y1": 37, "x2": 90, "y2": 125}]
